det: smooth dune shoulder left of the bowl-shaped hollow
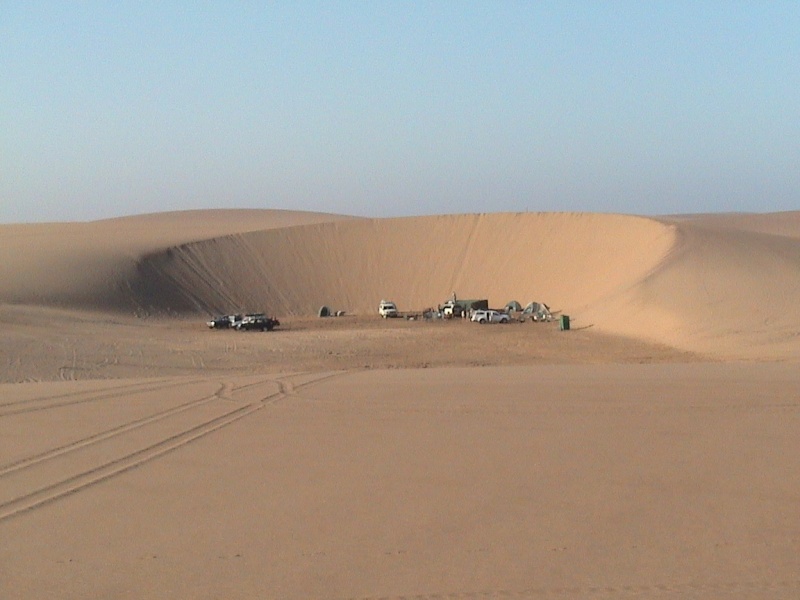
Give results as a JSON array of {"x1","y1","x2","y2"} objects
[{"x1": 0, "y1": 210, "x2": 350, "y2": 311}]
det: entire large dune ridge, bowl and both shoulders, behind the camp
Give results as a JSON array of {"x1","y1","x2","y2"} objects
[{"x1": 0, "y1": 211, "x2": 800, "y2": 358}]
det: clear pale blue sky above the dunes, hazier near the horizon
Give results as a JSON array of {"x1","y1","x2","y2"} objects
[{"x1": 0, "y1": 0, "x2": 800, "y2": 223}]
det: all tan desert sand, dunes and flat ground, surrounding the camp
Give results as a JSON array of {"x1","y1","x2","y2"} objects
[{"x1": 0, "y1": 210, "x2": 800, "y2": 600}]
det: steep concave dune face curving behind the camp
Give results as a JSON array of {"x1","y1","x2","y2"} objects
[{"x1": 136, "y1": 214, "x2": 674, "y2": 315}]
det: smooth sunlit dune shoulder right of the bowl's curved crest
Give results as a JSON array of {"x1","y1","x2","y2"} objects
[{"x1": 582, "y1": 213, "x2": 800, "y2": 360}]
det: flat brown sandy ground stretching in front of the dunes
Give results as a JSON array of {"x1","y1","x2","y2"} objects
[{"x1": 0, "y1": 307, "x2": 800, "y2": 599}]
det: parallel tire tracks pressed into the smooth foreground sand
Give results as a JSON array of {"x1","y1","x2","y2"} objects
[{"x1": 0, "y1": 372, "x2": 344, "y2": 522}]
